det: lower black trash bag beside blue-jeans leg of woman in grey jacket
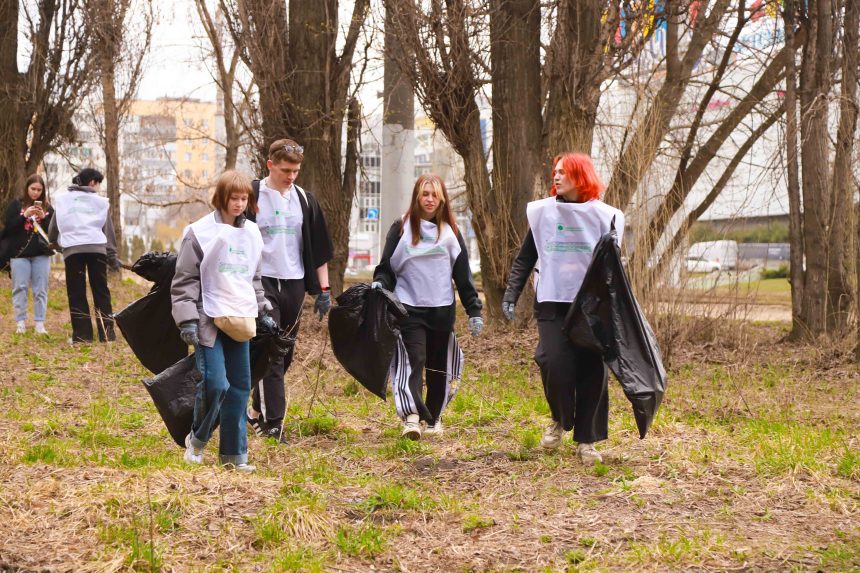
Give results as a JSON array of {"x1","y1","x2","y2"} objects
[{"x1": 143, "y1": 354, "x2": 203, "y2": 448}]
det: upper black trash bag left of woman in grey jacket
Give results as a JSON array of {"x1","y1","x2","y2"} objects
[{"x1": 114, "y1": 252, "x2": 188, "y2": 374}]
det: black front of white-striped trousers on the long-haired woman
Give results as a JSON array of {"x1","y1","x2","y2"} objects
[{"x1": 400, "y1": 318, "x2": 451, "y2": 425}]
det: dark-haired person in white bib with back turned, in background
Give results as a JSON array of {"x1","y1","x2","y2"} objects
[{"x1": 48, "y1": 167, "x2": 120, "y2": 343}]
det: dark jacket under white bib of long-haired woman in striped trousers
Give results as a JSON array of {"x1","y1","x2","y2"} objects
[{"x1": 373, "y1": 219, "x2": 483, "y2": 330}]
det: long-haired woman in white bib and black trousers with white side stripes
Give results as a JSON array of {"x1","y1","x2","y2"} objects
[{"x1": 371, "y1": 174, "x2": 484, "y2": 440}]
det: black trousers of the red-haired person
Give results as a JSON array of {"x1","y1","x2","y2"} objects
[{"x1": 535, "y1": 313, "x2": 609, "y2": 443}]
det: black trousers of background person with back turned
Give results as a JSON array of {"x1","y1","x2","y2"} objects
[{"x1": 65, "y1": 253, "x2": 116, "y2": 342}]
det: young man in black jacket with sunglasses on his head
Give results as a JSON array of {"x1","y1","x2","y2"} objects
[{"x1": 248, "y1": 139, "x2": 332, "y2": 443}]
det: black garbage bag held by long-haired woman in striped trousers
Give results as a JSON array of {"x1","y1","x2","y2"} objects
[{"x1": 328, "y1": 283, "x2": 407, "y2": 400}]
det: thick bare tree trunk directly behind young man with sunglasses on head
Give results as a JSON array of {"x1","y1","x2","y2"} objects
[{"x1": 221, "y1": 0, "x2": 370, "y2": 295}]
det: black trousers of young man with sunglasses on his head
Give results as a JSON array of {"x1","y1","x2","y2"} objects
[{"x1": 251, "y1": 277, "x2": 305, "y2": 424}]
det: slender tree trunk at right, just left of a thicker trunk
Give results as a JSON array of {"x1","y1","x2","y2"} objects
[{"x1": 783, "y1": 0, "x2": 805, "y2": 338}]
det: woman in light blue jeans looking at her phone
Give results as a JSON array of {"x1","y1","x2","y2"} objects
[{"x1": 0, "y1": 173, "x2": 54, "y2": 334}]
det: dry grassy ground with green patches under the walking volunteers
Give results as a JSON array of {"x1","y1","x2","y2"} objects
[{"x1": 0, "y1": 275, "x2": 860, "y2": 572}]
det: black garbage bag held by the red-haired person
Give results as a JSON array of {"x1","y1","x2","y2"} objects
[{"x1": 564, "y1": 221, "x2": 666, "y2": 438}]
